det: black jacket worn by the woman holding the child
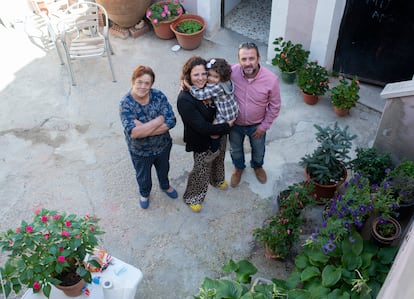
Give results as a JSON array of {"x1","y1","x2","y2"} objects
[{"x1": 177, "y1": 90, "x2": 230, "y2": 153}]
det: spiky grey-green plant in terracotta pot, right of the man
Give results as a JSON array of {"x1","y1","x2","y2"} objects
[{"x1": 299, "y1": 123, "x2": 356, "y2": 199}]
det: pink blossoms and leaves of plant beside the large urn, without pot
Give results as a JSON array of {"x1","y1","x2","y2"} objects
[{"x1": 146, "y1": 0, "x2": 184, "y2": 25}]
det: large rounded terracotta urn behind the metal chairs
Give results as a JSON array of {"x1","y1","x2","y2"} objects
[{"x1": 95, "y1": 0, "x2": 151, "y2": 28}]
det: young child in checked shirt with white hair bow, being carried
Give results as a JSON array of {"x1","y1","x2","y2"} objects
[{"x1": 190, "y1": 58, "x2": 239, "y2": 163}]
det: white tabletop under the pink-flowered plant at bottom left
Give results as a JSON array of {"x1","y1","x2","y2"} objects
[{"x1": 22, "y1": 257, "x2": 143, "y2": 299}]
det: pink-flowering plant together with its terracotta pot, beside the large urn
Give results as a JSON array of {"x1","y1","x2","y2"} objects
[{"x1": 146, "y1": 0, "x2": 184, "y2": 39}]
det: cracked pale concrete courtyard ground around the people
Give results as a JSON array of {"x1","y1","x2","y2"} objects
[{"x1": 0, "y1": 19, "x2": 384, "y2": 299}]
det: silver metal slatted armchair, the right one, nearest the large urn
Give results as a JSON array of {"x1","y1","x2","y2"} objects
[{"x1": 58, "y1": 1, "x2": 116, "y2": 86}]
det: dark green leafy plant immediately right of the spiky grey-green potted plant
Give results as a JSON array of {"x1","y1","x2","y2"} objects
[{"x1": 350, "y1": 147, "x2": 393, "y2": 185}]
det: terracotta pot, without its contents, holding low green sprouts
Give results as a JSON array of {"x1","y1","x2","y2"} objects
[{"x1": 170, "y1": 14, "x2": 206, "y2": 50}]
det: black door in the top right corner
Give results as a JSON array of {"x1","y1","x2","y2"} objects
[{"x1": 333, "y1": 0, "x2": 414, "y2": 85}]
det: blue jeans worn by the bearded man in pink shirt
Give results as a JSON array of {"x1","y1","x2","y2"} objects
[{"x1": 229, "y1": 125, "x2": 266, "y2": 169}]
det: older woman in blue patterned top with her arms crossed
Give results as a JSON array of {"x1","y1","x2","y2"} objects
[{"x1": 119, "y1": 65, "x2": 178, "y2": 209}]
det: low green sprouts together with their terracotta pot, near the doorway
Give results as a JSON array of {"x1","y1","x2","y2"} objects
[{"x1": 170, "y1": 13, "x2": 206, "y2": 50}]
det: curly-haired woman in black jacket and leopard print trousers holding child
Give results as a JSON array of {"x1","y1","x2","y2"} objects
[{"x1": 177, "y1": 56, "x2": 234, "y2": 212}]
